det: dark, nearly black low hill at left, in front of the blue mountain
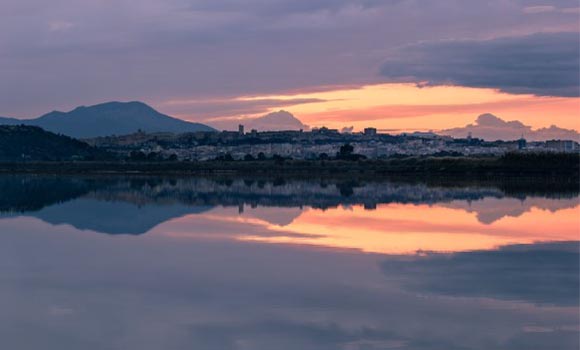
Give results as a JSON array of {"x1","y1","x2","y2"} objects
[{"x1": 0, "y1": 125, "x2": 108, "y2": 162}]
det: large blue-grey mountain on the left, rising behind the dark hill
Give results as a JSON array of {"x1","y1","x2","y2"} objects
[{"x1": 0, "y1": 102, "x2": 215, "y2": 138}]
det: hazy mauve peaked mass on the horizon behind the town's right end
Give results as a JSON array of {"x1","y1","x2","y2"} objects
[{"x1": 439, "y1": 113, "x2": 580, "y2": 141}]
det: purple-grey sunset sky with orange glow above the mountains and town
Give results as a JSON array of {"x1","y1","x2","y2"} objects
[{"x1": 0, "y1": 0, "x2": 580, "y2": 130}]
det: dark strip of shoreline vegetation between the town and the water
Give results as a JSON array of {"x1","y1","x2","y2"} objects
[{"x1": 0, "y1": 153, "x2": 580, "y2": 183}]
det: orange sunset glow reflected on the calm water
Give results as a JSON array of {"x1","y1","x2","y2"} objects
[{"x1": 155, "y1": 202, "x2": 580, "y2": 254}]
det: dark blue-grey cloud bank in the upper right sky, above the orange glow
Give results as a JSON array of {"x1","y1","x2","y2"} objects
[{"x1": 381, "y1": 32, "x2": 580, "y2": 97}]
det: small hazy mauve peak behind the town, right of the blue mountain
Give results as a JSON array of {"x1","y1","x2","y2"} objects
[{"x1": 212, "y1": 111, "x2": 308, "y2": 131}]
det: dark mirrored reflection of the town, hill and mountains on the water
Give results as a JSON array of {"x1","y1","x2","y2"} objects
[{"x1": 0, "y1": 175, "x2": 578, "y2": 234}]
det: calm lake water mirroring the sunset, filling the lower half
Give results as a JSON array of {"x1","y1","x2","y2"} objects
[{"x1": 0, "y1": 176, "x2": 580, "y2": 350}]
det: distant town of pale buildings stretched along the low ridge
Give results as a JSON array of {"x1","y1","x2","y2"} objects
[{"x1": 85, "y1": 125, "x2": 580, "y2": 161}]
